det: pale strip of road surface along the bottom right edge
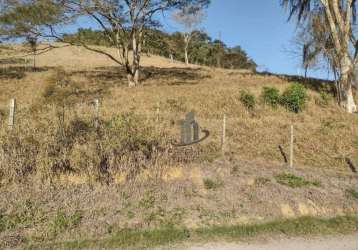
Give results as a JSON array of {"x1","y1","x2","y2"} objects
[{"x1": 189, "y1": 235, "x2": 358, "y2": 250}]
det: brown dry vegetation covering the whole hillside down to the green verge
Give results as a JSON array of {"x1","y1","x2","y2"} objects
[{"x1": 0, "y1": 46, "x2": 358, "y2": 247}]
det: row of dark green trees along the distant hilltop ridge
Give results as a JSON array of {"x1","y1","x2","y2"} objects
[{"x1": 61, "y1": 28, "x2": 257, "y2": 70}]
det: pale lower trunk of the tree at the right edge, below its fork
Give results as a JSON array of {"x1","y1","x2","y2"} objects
[{"x1": 340, "y1": 57, "x2": 357, "y2": 113}]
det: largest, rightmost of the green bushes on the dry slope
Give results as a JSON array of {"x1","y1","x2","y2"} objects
[{"x1": 281, "y1": 83, "x2": 308, "y2": 113}]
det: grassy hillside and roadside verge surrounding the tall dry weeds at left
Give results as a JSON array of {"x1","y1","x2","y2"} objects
[{"x1": 0, "y1": 44, "x2": 358, "y2": 248}]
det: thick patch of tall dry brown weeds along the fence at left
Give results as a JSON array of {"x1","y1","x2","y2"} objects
[{"x1": 0, "y1": 107, "x2": 182, "y2": 183}]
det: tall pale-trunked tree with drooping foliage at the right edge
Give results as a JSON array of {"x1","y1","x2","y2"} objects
[{"x1": 281, "y1": 0, "x2": 358, "y2": 113}]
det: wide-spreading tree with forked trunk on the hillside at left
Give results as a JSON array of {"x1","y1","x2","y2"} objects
[{"x1": 0, "y1": 0, "x2": 209, "y2": 87}]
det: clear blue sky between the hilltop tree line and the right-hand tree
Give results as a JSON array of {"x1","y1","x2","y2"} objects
[{"x1": 164, "y1": 0, "x2": 327, "y2": 78}]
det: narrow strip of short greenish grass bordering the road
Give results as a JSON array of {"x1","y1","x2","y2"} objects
[{"x1": 29, "y1": 216, "x2": 358, "y2": 249}]
